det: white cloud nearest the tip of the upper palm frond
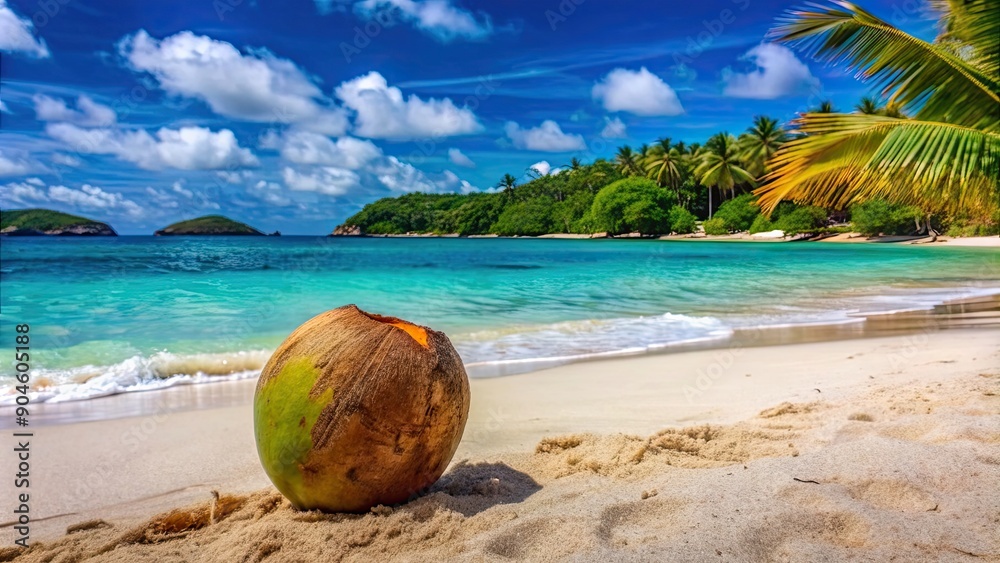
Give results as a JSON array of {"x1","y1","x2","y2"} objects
[{"x1": 722, "y1": 43, "x2": 820, "y2": 100}]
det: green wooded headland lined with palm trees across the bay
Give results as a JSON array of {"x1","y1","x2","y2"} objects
[{"x1": 333, "y1": 106, "x2": 1000, "y2": 240}]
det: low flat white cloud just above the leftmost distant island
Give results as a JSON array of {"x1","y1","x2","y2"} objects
[{"x1": 0, "y1": 182, "x2": 145, "y2": 218}]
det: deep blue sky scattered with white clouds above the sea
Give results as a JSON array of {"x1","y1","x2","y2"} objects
[{"x1": 0, "y1": 0, "x2": 934, "y2": 234}]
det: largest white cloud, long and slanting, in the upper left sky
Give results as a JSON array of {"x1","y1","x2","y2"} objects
[{"x1": 118, "y1": 31, "x2": 348, "y2": 135}]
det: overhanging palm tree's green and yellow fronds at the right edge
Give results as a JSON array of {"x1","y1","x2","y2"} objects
[{"x1": 756, "y1": 0, "x2": 1000, "y2": 214}]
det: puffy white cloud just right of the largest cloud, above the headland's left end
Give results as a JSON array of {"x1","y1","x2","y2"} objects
[{"x1": 336, "y1": 71, "x2": 482, "y2": 140}]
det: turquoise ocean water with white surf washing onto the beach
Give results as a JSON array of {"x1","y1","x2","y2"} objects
[{"x1": 0, "y1": 237, "x2": 1000, "y2": 405}]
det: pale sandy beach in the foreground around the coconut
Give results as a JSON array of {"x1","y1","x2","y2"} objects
[{"x1": 0, "y1": 330, "x2": 1000, "y2": 562}]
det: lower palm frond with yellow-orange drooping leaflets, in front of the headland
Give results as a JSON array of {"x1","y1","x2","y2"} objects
[{"x1": 755, "y1": 113, "x2": 1000, "y2": 213}]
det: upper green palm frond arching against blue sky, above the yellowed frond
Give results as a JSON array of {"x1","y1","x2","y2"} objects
[{"x1": 771, "y1": 0, "x2": 1000, "y2": 130}]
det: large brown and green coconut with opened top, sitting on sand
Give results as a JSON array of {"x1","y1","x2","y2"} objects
[{"x1": 254, "y1": 305, "x2": 469, "y2": 512}]
